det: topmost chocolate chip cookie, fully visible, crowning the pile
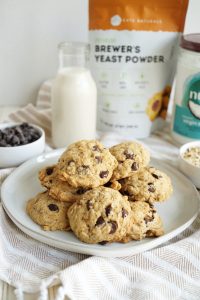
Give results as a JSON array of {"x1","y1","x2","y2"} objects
[{"x1": 58, "y1": 140, "x2": 117, "y2": 188}]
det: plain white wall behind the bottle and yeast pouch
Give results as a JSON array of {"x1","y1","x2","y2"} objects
[{"x1": 0, "y1": 0, "x2": 200, "y2": 106}]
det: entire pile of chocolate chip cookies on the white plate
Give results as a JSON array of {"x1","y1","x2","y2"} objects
[{"x1": 27, "y1": 140, "x2": 172, "y2": 245}]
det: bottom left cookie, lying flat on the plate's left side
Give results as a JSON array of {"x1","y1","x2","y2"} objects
[{"x1": 26, "y1": 192, "x2": 72, "y2": 231}]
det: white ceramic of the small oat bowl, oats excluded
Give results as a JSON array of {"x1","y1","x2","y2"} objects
[{"x1": 178, "y1": 141, "x2": 200, "y2": 189}]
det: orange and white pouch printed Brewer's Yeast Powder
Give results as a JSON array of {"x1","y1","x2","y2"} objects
[{"x1": 89, "y1": 0, "x2": 188, "y2": 138}]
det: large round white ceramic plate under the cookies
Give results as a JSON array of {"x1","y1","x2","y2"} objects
[{"x1": 1, "y1": 149, "x2": 200, "y2": 257}]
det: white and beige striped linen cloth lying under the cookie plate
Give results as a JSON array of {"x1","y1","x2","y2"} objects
[{"x1": 0, "y1": 82, "x2": 200, "y2": 300}]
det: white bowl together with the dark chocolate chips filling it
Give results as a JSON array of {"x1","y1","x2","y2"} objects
[{"x1": 0, "y1": 123, "x2": 45, "y2": 168}]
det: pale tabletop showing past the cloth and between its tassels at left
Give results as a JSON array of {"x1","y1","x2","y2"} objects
[{"x1": 0, "y1": 107, "x2": 58, "y2": 300}]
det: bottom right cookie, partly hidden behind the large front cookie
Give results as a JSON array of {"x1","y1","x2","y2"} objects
[{"x1": 123, "y1": 201, "x2": 164, "y2": 242}]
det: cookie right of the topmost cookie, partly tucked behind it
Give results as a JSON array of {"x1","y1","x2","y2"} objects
[{"x1": 109, "y1": 142, "x2": 150, "y2": 181}]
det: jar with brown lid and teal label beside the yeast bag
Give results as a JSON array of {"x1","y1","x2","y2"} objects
[{"x1": 172, "y1": 33, "x2": 200, "y2": 144}]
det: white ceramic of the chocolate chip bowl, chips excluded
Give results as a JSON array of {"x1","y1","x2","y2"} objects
[{"x1": 0, "y1": 123, "x2": 45, "y2": 168}]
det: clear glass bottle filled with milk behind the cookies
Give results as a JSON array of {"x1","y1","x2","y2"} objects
[{"x1": 51, "y1": 42, "x2": 97, "y2": 148}]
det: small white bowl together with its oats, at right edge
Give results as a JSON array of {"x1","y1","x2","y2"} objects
[{"x1": 179, "y1": 141, "x2": 200, "y2": 189}]
